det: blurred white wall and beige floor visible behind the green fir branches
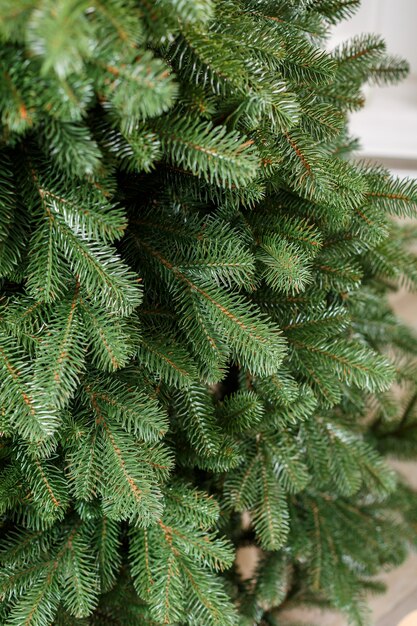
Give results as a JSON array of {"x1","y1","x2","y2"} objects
[{"x1": 239, "y1": 0, "x2": 417, "y2": 626}]
